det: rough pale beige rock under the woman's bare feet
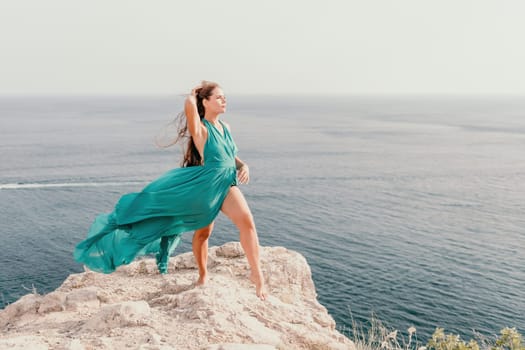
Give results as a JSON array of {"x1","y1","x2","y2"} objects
[{"x1": 0, "y1": 242, "x2": 355, "y2": 350}]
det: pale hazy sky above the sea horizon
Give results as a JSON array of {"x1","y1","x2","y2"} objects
[{"x1": 0, "y1": 0, "x2": 525, "y2": 95}]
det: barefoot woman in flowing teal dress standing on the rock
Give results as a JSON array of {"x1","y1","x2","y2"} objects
[{"x1": 74, "y1": 81, "x2": 267, "y2": 300}]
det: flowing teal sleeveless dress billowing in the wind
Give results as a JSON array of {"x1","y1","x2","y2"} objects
[{"x1": 73, "y1": 119, "x2": 237, "y2": 273}]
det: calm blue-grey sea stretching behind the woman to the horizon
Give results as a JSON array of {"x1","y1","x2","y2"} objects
[{"x1": 0, "y1": 96, "x2": 525, "y2": 339}]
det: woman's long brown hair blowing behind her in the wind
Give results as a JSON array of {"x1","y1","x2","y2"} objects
[{"x1": 156, "y1": 80, "x2": 219, "y2": 167}]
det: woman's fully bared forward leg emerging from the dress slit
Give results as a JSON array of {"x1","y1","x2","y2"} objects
[{"x1": 221, "y1": 186, "x2": 268, "y2": 300}]
